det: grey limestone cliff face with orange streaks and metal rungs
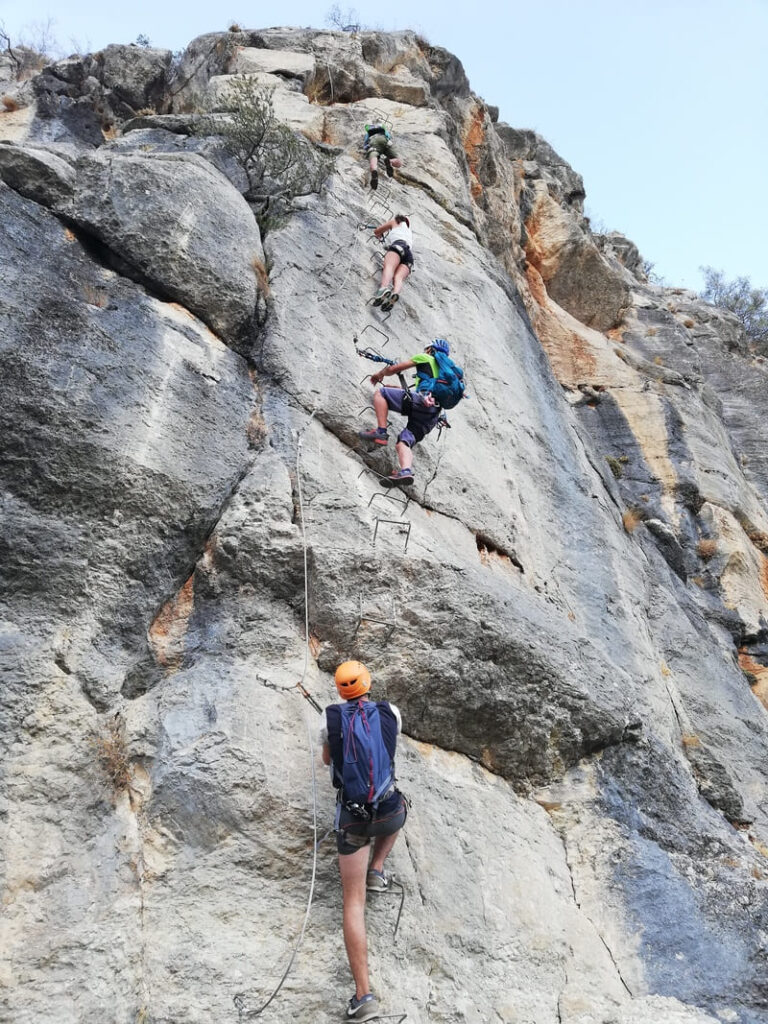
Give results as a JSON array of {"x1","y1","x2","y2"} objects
[{"x1": 0, "y1": 29, "x2": 768, "y2": 1024}]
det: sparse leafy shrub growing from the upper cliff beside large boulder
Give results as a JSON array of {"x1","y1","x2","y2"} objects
[{"x1": 207, "y1": 76, "x2": 334, "y2": 231}]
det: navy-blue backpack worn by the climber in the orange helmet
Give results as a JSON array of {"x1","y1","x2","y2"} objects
[{"x1": 336, "y1": 700, "x2": 394, "y2": 807}]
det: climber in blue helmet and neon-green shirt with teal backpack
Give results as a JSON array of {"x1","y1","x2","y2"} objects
[{"x1": 358, "y1": 338, "x2": 464, "y2": 487}]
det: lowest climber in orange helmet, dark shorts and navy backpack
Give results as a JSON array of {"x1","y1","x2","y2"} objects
[{"x1": 321, "y1": 662, "x2": 408, "y2": 1021}]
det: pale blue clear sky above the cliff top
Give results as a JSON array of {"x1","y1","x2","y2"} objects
[{"x1": 0, "y1": 0, "x2": 768, "y2": 290}]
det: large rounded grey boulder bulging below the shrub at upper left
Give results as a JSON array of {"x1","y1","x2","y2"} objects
[{"x1": 58, "y1": 151, "x2": 263, "y2": 348}]
